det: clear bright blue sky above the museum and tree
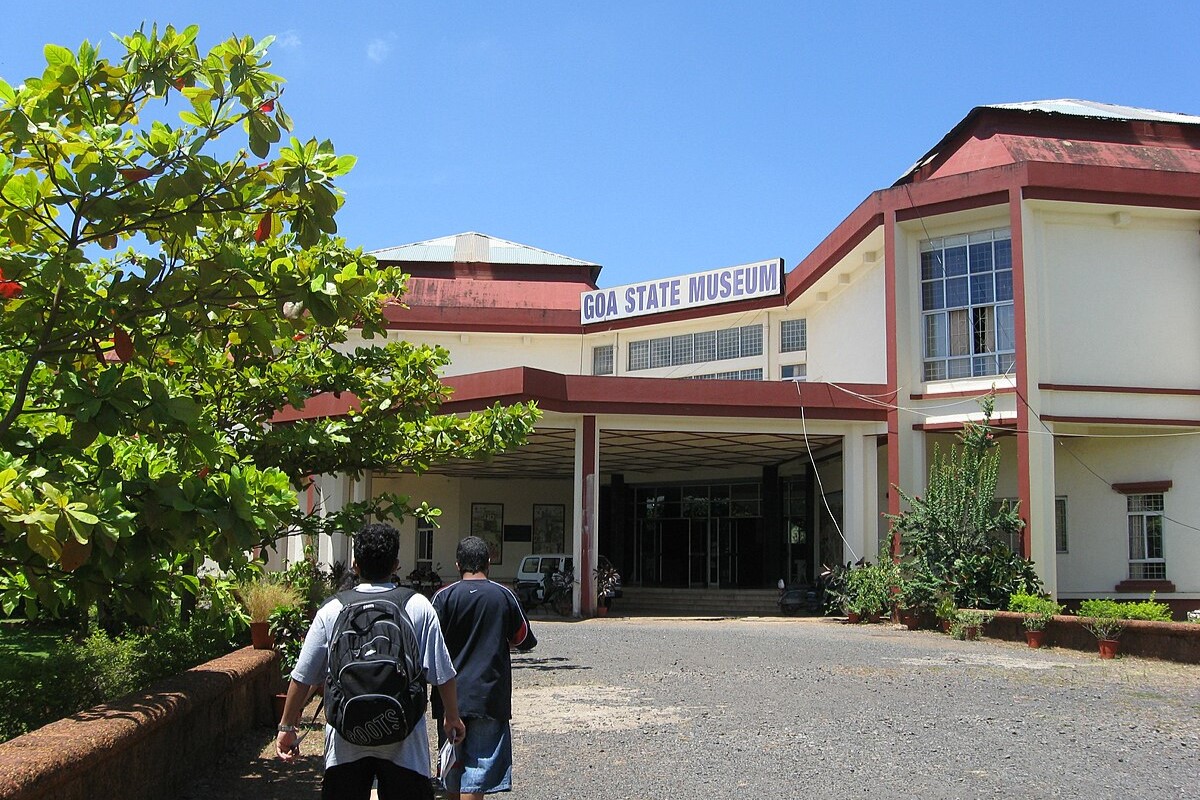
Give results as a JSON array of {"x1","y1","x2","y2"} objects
[{"x1": 0, "y1": 0, "x2": 1200, "y2": 285}]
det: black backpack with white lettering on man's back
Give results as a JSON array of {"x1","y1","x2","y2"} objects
[{"x1": 325, "y1": 589, "x2": 426, "y2": 747}]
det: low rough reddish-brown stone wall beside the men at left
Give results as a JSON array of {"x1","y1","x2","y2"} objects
[{"x1": 0, "y1": 648, "x2": 278, "y2": 800}]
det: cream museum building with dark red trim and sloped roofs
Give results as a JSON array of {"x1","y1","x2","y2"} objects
[{"x1": 275, "y1": 100, "x2": 1200, "y2": 615}]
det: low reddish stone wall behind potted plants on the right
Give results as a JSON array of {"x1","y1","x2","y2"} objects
[{"x1": 984, "y1": 612, "x2": 1200, "y2": 664}]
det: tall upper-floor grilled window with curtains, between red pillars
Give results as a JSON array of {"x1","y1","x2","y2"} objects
[{"x1": 920, "y1": 228, "x2": 1016, "y2": 380}]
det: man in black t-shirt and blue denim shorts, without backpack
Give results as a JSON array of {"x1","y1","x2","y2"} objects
[{"x1": 433, "y1": 536, "x2": 538, "y2": 800}]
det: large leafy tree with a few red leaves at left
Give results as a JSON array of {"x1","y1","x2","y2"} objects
[{"x1": 0, "y1": 26, "x2": 538, "y2": 621}]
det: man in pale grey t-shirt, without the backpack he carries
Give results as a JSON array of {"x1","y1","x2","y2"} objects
[{"x1": 275, "y1": 523, "x2": 466, "y2": 800}]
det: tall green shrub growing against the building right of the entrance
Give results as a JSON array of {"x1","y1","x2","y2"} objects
[{"x1": 888, "y1": 393, "x2": 1042, "y2": 608}]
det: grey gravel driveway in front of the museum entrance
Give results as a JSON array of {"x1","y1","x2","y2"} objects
[{"x1": 182, "y1": 618, "x2": 1200, "y2": 800}]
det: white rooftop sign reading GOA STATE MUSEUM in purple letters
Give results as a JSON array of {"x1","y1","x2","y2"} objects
[{"x1": 580, "y1": 258, "x2": 784, "y2": 325}]
